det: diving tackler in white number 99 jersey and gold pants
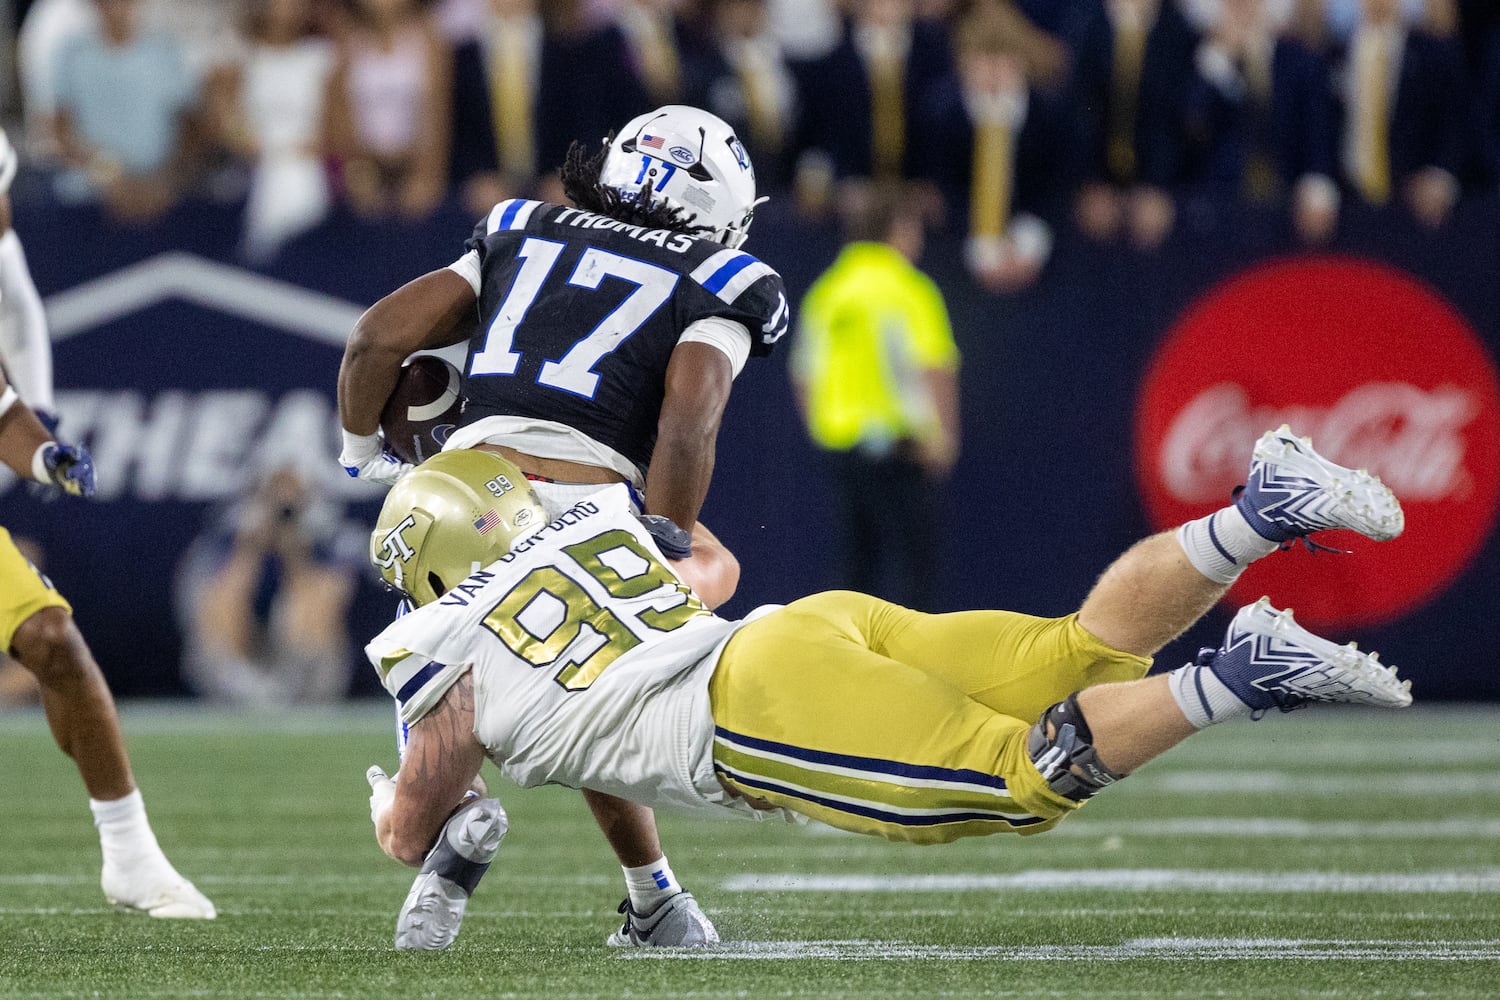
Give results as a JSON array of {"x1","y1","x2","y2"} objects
[{"x1": 368, "y1": 440, "x2": 1412, "y2": 945}]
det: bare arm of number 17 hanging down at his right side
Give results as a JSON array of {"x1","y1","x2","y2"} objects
[{"x1": 647, "y1": 335, "x2": 734, "y2": 529}]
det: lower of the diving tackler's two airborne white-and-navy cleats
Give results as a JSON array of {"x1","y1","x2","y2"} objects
[{"x1": 1200, "y1": 597, "x2": 1412, "y2": 712}]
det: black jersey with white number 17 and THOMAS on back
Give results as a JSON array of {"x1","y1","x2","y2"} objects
[{"x1": 453, "y1": 199, "x2": 791, "y2": 471}]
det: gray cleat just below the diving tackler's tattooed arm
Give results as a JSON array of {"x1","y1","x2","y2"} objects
[{"x1": 396, "y1": 799, "x2": 509, "y2": 952}]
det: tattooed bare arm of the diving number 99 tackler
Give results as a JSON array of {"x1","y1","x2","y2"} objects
[{"x1": 375, "y1": 673, "x2": 485, "y2": 868}]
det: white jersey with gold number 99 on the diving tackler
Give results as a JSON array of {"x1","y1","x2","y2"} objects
[{"x1": 366, "y1": 486, "x2": 762, "y2": 814}]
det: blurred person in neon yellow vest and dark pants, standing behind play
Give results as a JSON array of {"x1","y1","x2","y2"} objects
[{"x1": 791, "y1": 184, "x2": 959, "y2": 610}]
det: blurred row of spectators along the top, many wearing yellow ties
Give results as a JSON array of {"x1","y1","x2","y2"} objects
[{"x1": 2, "y1": 0, "x2": 1500, "y2": 284}]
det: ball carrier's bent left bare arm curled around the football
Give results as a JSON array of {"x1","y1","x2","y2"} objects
[{"x1": 339, "y1": 268, "x2": 479, "y2": 435}]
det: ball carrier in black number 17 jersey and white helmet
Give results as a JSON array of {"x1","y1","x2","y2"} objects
[{"x1": 339, "y1": 105, "x2": 791, "y2": 945}]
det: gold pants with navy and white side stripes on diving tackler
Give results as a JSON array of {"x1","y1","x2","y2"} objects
[{"x1": 708, "y1": 591, "x2": 1151, "y2": 844}]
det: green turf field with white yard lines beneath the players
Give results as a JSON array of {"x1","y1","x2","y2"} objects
[{"x1": 0, "y1": 705, "x2": 1500, "y2": 1000}]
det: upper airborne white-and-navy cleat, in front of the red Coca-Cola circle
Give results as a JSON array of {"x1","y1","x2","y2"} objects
[{"x1": 1235, "y1": 424, "x2": 1406, "y2": 541}]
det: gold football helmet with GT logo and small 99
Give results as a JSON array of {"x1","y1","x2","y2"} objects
[{"x1": 371, "y1": 450, "x2": 548, "y2": 607}]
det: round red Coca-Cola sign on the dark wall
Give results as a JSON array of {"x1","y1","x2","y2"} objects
[{"x1": 1136, "y1": 258, "x2": 1500, "y2": 627}]
